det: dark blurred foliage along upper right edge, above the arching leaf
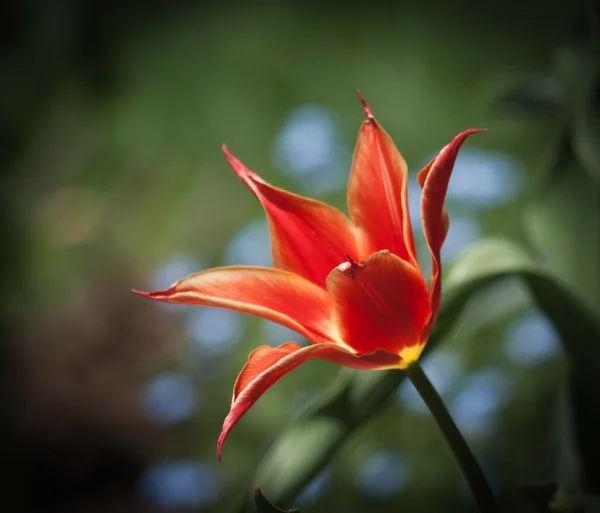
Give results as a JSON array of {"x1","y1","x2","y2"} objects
[{"x1": 496, "y1": 14, "x2": 600, "y2": 312}]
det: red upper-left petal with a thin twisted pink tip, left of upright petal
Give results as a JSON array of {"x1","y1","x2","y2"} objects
[{"x1": 223, "y1": 146, "x2": 357, "y2": 288}]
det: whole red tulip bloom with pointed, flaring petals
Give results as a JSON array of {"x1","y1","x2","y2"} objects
[{"x1": 134, "y1": 93, "x2": 482, "y2": 459}]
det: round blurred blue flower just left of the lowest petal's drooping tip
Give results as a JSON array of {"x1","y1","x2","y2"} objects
[{"x1": 142, "y1": 372, "x2": 198, "y2": 426}]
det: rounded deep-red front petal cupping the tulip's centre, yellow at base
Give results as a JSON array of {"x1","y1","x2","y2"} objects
[{"x1": 327, "y1": 251, "x2": 431, "y2": 361}]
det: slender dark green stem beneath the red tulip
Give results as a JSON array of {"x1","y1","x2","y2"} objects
[{"x1": 404, "y1": 362, "x2": 498, "y2": 513}]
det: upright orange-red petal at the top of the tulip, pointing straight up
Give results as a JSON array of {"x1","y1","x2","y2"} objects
[{"x1": 348, "y1": 93, "x2": 417, "y2": 266}]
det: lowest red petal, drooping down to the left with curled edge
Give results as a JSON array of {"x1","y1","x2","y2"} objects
[{"x1": 217, "y1": 342, "x2": 402, "y2": 460}]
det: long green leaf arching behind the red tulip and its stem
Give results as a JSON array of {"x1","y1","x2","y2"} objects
[{"x1": 241, "y1": 240, "x2": 600, "y2": 512}]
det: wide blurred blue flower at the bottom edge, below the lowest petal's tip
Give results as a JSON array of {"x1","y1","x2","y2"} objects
[{"x1": 139, "y1": 460, "x2": 222, "y2": 508}]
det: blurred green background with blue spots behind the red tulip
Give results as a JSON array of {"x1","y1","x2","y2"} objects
[{"x1": 0, "y1": 0, "x2": 600, "y2": 513}]
